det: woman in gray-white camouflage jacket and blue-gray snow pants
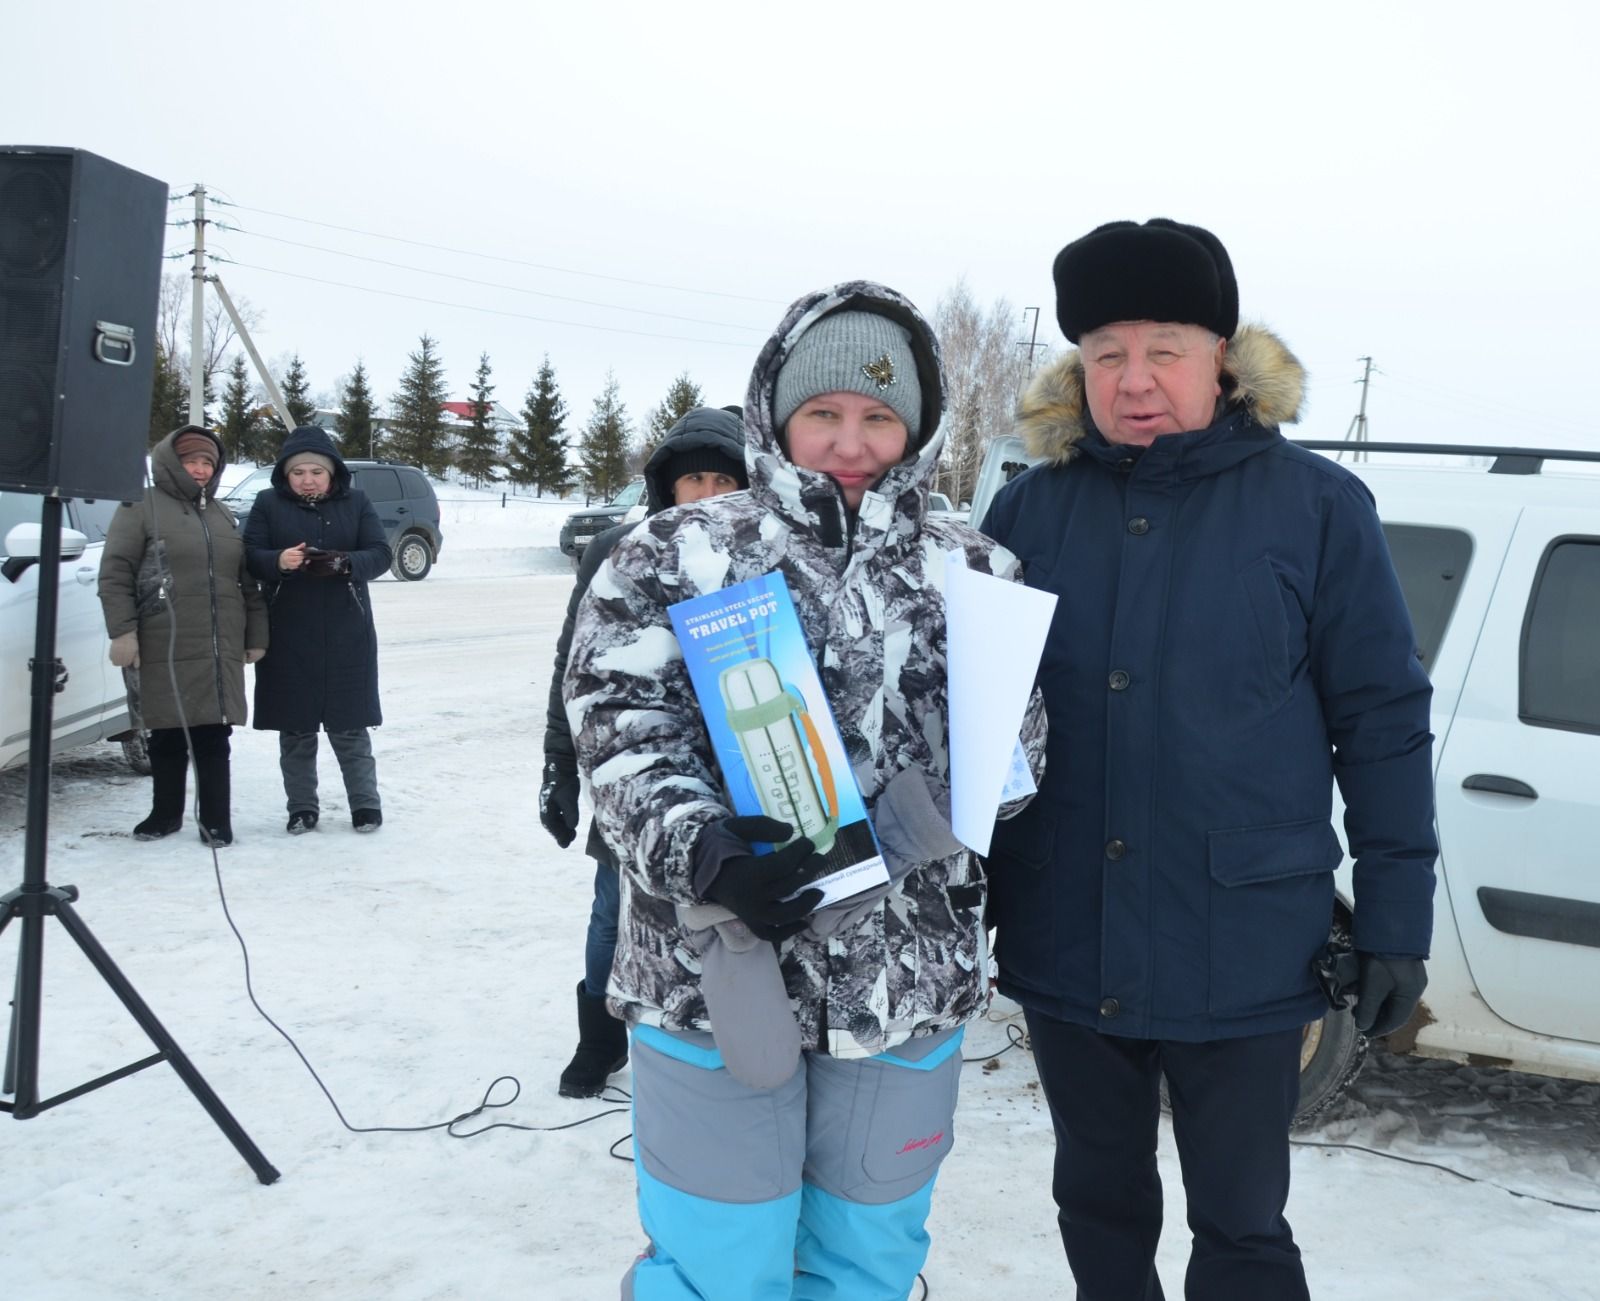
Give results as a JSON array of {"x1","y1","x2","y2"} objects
[{"x1": 565, "y1": 282, "x2": 1045, "y2": 1298}]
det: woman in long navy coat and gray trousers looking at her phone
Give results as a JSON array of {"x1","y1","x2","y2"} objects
[{"x1": 245, "y1": 426, "x2": 390, "y2": 835}]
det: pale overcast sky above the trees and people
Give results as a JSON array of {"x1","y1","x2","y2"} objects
[{"x1": 0, "y1": 0, "x2": 1600, "y2": 446}]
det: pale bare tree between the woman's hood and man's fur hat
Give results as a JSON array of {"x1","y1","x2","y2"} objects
[{"x1": 933, "y1": 278, "x2": 1029, "y2": 502}]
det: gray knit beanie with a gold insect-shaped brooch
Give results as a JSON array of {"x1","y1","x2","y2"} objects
[{"x1": 773, "y1": 312, "x2": 922, "y2": 445}]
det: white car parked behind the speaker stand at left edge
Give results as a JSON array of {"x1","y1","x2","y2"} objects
[{"x1": 0, "y1": 493, "x2": 149, "y2": 773}]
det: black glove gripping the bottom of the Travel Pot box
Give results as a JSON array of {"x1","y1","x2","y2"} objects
[{"x1": 694, "y1": 816, "x2": 822, "y2": 944}]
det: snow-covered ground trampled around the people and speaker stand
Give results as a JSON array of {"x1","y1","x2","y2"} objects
[{"x1": 0, "y1": 485, "x2": 1600, "y2": 1301}]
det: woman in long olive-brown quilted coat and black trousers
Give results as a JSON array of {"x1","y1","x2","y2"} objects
[{"x1": 99, "y1": 424, "x2": 267, "y2": 845}]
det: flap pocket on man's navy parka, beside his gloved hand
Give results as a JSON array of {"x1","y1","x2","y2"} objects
[{"x1": 1206, "y1": 818, "x2": 1342, "y2": 1015}]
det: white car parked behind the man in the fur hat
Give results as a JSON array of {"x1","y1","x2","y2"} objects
[{"x1": 973, "y1": 437, "x2": 1600, "y2": 1122}]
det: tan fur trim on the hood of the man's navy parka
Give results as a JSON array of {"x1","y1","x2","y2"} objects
[{"x1": 1016, "y1": 325, "x2": 1306, "y2": 466}]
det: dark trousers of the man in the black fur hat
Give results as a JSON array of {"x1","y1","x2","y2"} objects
[{"x1": 1027, "y1": 1011, "x2": 1309, "y2": 1301}]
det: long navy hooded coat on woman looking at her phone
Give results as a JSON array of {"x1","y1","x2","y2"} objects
[{"x1": 245, "y1": 426, "x2": 390, "y2": 731}]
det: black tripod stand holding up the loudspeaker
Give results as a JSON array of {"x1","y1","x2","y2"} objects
[{"x1": 0, "y1": 496, "x2": 278, "y2": 1184}]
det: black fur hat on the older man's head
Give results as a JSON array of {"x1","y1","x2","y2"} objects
[{"x1": 1053, "y1": 218, "x2": 1238, "y2": 342}]
